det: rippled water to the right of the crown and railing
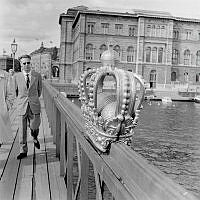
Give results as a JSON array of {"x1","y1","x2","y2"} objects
[{"x1": 133, "y1": 101, "x2": 200, "y2": 198}]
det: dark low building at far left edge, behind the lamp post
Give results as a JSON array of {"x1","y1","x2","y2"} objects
[{"x1": 0, "y1": 55, "x2": 21, "y2": 72}]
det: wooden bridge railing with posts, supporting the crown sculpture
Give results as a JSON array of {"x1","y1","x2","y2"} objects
[{"x1": 43, "y1": 82, "x2": 197, "y2": 200}]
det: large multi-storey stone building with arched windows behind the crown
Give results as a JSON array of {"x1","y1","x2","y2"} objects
[{"x1": 59, "y1": 6, "x2": 200, "y2": 88}]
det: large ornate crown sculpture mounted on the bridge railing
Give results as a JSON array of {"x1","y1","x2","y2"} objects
[{"x1": 79, "y1": 49, "x2": 145, "y2": 152}]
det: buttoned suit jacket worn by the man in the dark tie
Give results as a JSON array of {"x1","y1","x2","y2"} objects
[{"x1": 13, "y1": 70, "x2": 42, "y2": 115}]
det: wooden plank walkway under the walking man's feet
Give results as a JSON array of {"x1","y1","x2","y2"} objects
[{"x1": 0, "y1": 98, "x2": 67, "y2": 200}]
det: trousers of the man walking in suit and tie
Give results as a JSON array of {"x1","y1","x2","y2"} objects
[{"x1": 19, "y1": 104, "x2": 41, "y2": 153}]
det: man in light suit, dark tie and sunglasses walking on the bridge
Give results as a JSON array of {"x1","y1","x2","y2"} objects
[{"x1": 13, "y1": 55, "x2": 42, "y2": 159}]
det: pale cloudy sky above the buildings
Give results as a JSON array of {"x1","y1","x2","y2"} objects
[{"x1": 0, "y1": 0, "x2": 200, "y2": 57}]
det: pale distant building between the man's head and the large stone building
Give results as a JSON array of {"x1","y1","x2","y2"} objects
[{"x1": 30, "y1": 43, "x2": 59, "y2": 78}]
